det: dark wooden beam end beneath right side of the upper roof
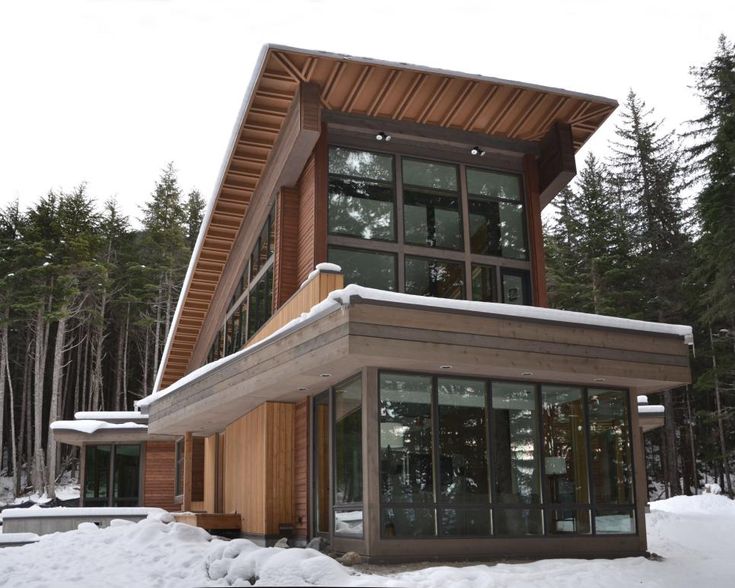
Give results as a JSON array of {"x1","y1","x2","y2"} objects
[{"x1": 538, "y1": 122, "x2": 577, "y2": 209}]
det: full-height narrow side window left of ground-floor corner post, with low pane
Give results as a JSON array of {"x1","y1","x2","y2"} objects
[{"x1": 334, "y1": 376, "x2": 362, "y2": 536}]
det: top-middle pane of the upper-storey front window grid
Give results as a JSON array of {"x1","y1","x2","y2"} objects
[{"x1": 403, "y1": 159, "x2": 463, "y2": 250}]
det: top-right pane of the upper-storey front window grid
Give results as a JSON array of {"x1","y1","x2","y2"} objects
[{"x1": 467, "y1": 167, "x2": 528, "y2": 259}]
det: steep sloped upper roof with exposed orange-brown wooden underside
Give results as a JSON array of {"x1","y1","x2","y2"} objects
[{"x1": 155, "y1": 45, "x2": 617, "y2": 390}]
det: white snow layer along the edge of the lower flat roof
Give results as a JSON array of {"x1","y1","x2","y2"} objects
[{"x1": 135, "y1": 284, "x2": 694, "y2": 408}]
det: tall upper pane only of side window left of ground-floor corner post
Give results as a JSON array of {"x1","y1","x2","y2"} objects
[{"x1": 334, "y1": 376, "x2": 362, "y2": 504}]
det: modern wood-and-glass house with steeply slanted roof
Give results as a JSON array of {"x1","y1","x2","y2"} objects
[{"x1": 49, "y1": 46, "x2": 691, "y2": 561}]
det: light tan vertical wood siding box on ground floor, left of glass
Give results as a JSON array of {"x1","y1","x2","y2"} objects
[{"x1": 223, "y1": 402, "x2": 294, "y2": 536}]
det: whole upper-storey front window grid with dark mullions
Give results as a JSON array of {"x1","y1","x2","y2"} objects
[{"x1": 328, "y1": 146, "x2": 531, "y2": 304}]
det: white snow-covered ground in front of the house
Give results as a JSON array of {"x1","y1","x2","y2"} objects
[{"x1": 0, "y1": 494, "x2": 735, "y2": 588}]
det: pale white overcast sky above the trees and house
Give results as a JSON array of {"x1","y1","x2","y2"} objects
[{"x1": 0, "y1": 0, "x2": 735, "y2": 225}]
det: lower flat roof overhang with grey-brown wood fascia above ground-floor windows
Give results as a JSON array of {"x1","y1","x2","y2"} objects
[{"x1": 147, "y1": 286, "x2": 690, "y2": 435}]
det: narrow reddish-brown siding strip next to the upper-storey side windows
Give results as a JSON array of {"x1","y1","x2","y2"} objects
[{"x1": 273, "y1": 188, "x2": 299, "y2": 309}]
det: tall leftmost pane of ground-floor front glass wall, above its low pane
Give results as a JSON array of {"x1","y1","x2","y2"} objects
[{"x1": 380, "y1": 373, "x2": 434, "y2": 503}]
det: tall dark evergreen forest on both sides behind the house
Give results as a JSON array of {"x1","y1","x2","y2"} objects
[{"x1": 0, "y1": 36, "x2": 735, "y2": 499}]
